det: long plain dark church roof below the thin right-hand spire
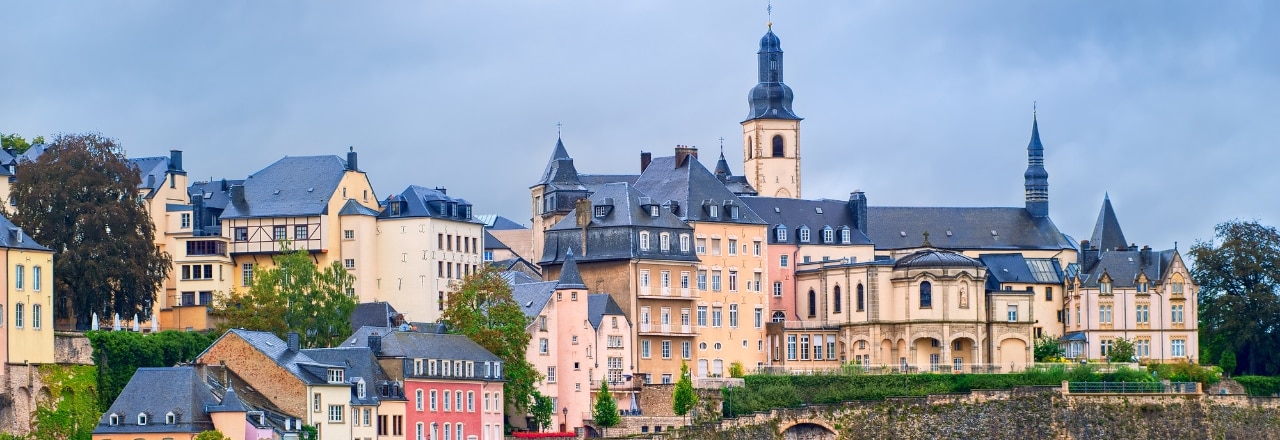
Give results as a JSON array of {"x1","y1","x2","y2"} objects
[{"x1": 867, "y1": 206, "x2": 1075, "y2": 249}]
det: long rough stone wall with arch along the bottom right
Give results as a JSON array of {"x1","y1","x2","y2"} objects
[{"x1": 675, "y1": 388, "x2": 1280, "y2": 440}]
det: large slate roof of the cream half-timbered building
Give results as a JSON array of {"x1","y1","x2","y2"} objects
[{"x1": 223, "y1": 155, "x2": 347, "y2": 219}]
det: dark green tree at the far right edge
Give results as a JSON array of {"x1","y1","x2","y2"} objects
[{"x1": 1188, "y1": 220, "x2": 1280, "y2": 375}]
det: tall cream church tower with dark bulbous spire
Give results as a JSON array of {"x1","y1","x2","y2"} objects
[{"x1": 742, "y1": 23, "x2": 801, "y2": 198}]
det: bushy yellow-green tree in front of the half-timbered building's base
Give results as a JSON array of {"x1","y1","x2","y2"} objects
[{"x1": 215, "y1": 242, "x2": 356, "y2": 347}]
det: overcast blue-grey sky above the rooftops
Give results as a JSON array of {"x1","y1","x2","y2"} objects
[{"x1": 0, "y1": 0, "x2": 1280, "y2": 249}]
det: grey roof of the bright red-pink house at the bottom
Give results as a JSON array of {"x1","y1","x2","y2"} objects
[{"x1": 342, "y1": 326, "x2": 502, "y2": 362}]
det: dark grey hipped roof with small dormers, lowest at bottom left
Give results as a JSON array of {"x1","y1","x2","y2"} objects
[{"x1": 93, "y1": 366, "x2": 219, "y2": 435}]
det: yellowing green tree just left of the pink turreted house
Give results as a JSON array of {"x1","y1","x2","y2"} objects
[{"x1": 440, "y1": 265, "x2": 537, "y2": 411}]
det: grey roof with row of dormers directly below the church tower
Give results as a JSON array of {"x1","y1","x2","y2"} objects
[{"x1": 742, "y1": 197, "x2": 875, "y2": 246}]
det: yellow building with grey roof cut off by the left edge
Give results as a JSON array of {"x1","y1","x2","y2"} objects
[{"x1": 0, "y1": 216, "x2": 54, "y2": 365}]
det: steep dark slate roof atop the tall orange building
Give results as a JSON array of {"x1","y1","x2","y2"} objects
[{"x1": 635, "y1": 155, "x2": 764, "y2": 224}]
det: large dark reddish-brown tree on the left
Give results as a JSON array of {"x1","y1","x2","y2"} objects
[{"x1": 10, "y1": 134, "x2": 172, "y2": 324}]
